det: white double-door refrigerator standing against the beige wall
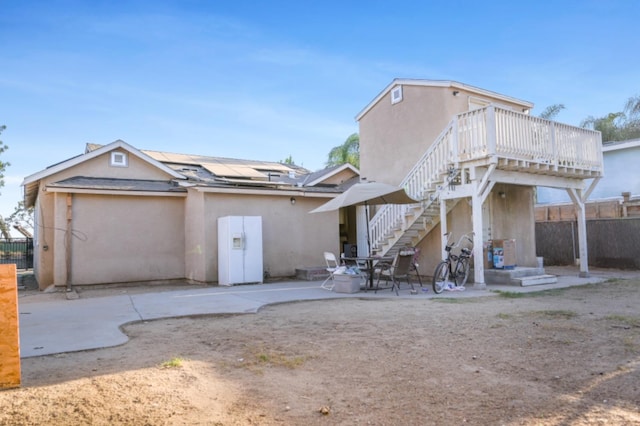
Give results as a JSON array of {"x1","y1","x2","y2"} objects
[{"x1": 218, "y1": 216, "x2": 263, "y2": 285}]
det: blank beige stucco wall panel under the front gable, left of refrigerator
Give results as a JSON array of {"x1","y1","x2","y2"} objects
[{"x1": 71, "y1": 194, "x2": 185, "y2": 285}]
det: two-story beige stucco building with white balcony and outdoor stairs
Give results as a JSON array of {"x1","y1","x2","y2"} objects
[{"x1": 348, "y1": 79, "x2": 603, "y2": 288}]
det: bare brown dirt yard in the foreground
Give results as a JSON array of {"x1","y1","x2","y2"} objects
[{"x1": 0, "y1": 280, "x2": 640, "y2": 425}]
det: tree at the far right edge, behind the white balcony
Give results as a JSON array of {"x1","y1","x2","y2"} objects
[{"x1": 580, "y1": 95, "x2": 640, "y2": 142}]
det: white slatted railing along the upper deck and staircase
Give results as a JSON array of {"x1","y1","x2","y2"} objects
[{"x1": 370, "y1": 106, "x2": 603, "y2": 255}]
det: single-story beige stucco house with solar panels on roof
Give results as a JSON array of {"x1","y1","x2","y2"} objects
[{"x1": 22, "y1": 140, "x2": 358, "y2": 289}]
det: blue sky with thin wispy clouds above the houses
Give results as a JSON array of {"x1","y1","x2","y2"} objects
[{"x1": 0, "y1": 0, "x2": 640, "y2": 220}]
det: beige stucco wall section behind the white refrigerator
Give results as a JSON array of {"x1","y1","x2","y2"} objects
[{"x1": 187, "y1": 191, "x2": 340, "y2": 282}]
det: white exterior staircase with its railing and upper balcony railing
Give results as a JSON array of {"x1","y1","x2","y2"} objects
[{"x1": 369, "y1": 105, "x2": 603, "y2": 256}]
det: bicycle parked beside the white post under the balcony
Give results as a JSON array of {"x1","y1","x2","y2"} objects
[{"x1": 433, "y1": 232, "x2": 473, "y2": 294}]
